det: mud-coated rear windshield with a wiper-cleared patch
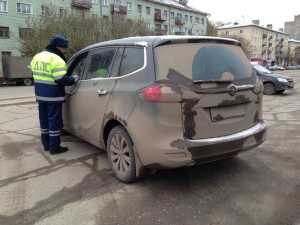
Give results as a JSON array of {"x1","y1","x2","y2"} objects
[{"x1": 154, "y1": 43, "x2": 252, "y2": 82}]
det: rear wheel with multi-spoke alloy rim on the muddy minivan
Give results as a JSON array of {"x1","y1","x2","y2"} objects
[{"x1": 107, "y1": 126, "x2": 137, "y2": 183}]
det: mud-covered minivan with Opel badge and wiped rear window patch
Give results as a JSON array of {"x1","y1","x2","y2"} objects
[{"x1": 63, "y1": 36, "x2": 266, "y2": 182}]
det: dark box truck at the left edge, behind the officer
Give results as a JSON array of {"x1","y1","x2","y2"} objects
[{"x1": 1, "y1": 56, "x2": 33, "y2": 86}]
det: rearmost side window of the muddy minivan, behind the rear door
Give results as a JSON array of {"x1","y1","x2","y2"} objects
[{"x1": 120, "y1": 47, "x2": 144, "y2": 76}]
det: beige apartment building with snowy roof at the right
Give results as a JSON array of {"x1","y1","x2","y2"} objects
[{"x1": 218, "y1": 20, "x2": 300, "y2": 65}]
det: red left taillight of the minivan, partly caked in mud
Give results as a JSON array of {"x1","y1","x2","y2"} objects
[{"x1": 138, "y1": 83, "x2": 181, "y2": 102}]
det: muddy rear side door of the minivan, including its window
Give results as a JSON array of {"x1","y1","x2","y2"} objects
[{"x1": 68, "y1": 47, "x2": 119, "y2": 147}]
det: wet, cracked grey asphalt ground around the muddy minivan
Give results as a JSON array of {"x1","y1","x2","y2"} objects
[{"x1": 0, "y1": 71, "x2": 300, "y2": 225}]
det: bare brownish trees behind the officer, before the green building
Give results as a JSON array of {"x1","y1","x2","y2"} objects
[{"x1": 19, "y1": 5, "x2": 153, "y2": 56}]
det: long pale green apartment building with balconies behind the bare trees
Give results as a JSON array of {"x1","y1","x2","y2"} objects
[{"x1": 0, "y1": 0, "x2": 210, "y2": 78}]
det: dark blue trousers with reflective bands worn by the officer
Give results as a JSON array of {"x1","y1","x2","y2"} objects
[{"x1": 38, "y1": 102, "x2": 63, "y2": 151}]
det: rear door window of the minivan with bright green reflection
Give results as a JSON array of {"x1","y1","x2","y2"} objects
[{"x1": 86, "y1": 48, "x2": 117, "y2": 79}]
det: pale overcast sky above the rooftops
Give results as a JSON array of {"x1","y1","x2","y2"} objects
[{"x1": 188, "y1": 0, "x2": 300, "y2": 30}]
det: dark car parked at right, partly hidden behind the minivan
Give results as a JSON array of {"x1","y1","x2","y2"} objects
[{"x1": 251, "y1": 63, "x2": 294, "y2": 95}]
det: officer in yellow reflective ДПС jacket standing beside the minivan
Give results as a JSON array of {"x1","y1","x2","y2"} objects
[{"x1": 30, "y1": 34, "x2": 78, "y2": 155}]
